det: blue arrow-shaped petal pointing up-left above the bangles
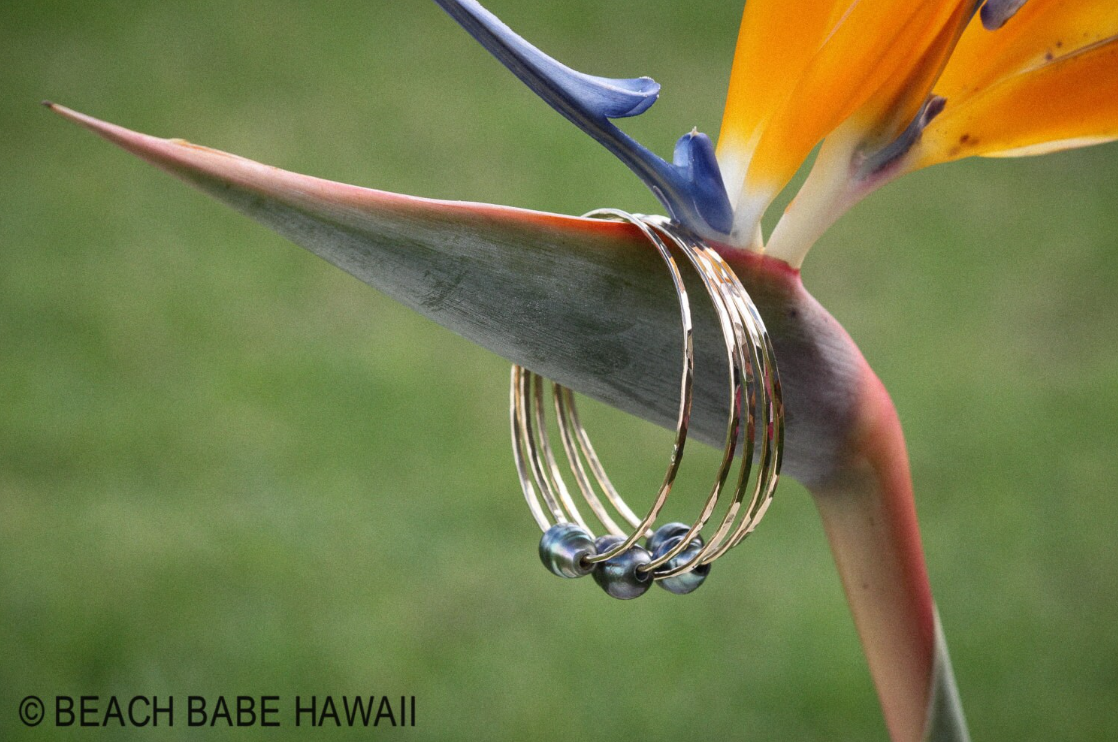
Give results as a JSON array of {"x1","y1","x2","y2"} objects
[{"x1": 435, "y1": 0, "x2": 732, "y2": 238}]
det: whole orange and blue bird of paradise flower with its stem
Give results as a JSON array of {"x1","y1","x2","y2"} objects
[{"x1": 51, "y1": 0, "x2": 1118, "y2": 740}]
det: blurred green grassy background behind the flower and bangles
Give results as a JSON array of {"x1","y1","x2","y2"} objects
[{"x1": 0, "y1": 0, "x2": 1118, "y2": 740}]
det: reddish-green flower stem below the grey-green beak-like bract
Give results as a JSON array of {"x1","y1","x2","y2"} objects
[{"x1": 813, "y1": 365, "x2": 968, "y2": 742}]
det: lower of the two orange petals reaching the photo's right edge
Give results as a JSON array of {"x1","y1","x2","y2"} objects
[{"x1": 909, "y1": 36, "x2": 1118, "y2": 170}]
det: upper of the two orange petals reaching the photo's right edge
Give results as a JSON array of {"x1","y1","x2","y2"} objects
[{"x1": 936, "y1": 0, "x2": 1118, "y2": 102}]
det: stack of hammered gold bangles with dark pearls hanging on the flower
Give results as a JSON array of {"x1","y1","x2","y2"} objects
[{"x1": 510, "y1": 209, "x2": 784, "y2": 600}]
